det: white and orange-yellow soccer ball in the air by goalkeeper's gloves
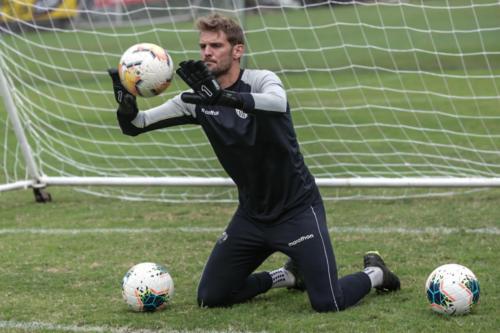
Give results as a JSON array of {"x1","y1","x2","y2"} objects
[{"x1": 118, "y1": 43, "x2": 174, "y2": 97}]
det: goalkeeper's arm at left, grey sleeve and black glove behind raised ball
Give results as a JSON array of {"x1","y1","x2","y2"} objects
[{"x1": 108, "y1": 69, "x2": 197, "y2": 136}]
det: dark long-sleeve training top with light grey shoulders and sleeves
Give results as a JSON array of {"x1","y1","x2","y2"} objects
[{"x1": 118, "y1": 69, "x2": 319, "y2": 223}]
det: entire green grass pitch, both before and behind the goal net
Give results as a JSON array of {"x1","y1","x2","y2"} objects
[{"x1": 0, "y1": 0, "x2": 500, "y2": 333}]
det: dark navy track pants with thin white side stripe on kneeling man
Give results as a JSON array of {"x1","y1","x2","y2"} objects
[{"x1": 198, "y1": 201, "x2": 371, "y2": 312}]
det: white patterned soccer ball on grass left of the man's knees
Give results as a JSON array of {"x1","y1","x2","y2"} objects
[{"x1": 122, "y1": 262, "x2": 174, "y2": 312}]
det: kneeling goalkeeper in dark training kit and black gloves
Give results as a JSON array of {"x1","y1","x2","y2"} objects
[{"x1": 109, "y1": 14, "x2": 400, "y2": 312}]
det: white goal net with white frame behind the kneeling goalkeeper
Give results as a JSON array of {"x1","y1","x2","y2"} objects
[{"x1": 0, "y1": 0, "x2": 500, "y2": 201}]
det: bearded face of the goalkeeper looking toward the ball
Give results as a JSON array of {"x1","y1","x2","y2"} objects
[{"x1": 200, "y1": 31, "x2": 241, "y2": 77}]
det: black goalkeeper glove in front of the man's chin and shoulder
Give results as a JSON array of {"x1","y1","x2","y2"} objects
[{"x1": 176, "y1": 60, "x2": 245, "y2": 110}]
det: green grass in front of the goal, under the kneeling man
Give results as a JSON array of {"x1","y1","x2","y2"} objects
[{"x1": 0, "y1": 188, "x2": 500, "y2": 332}]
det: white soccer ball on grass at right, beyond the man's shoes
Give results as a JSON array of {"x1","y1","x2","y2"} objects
[{"x1": 425, "y1": 264, "x2": 479, "y2": 315}]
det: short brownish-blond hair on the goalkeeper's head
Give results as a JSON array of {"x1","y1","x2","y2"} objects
[{"x1": 196, "y1": 13, "x2": 245, "y2": 46}]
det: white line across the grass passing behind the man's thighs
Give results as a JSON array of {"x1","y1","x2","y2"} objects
[{"x1": 0, "y1": 227, "x2": 500, "y2": 235}]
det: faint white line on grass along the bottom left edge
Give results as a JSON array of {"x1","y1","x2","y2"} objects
[{"x1": 0, "y1": 320, "x2": 260, "y2": 333}]
